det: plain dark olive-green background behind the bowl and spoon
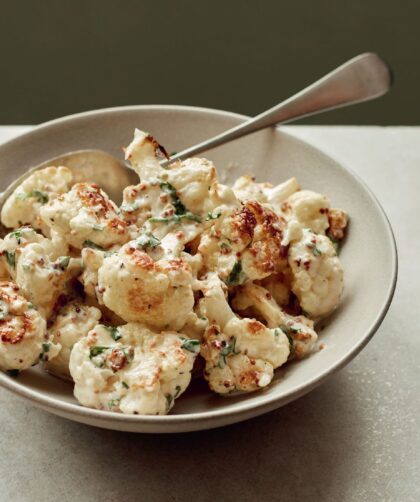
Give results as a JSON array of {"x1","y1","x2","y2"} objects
[{"x1": 0, "y1": 0, "x2": 420, "y2": 124}]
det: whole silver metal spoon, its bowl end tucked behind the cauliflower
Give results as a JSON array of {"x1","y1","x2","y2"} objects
[{"x1": 0, "y1": 53, "x2": 392, "y2": 207}]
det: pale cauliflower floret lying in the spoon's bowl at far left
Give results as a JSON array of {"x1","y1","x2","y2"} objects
[{"x1": 1, "y1": 166, "x2": 72, "y2": 235}]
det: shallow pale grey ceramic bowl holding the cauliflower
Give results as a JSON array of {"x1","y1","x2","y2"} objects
[{"x1": 0, "y1": 106, "x2": 397, "y2": 432}]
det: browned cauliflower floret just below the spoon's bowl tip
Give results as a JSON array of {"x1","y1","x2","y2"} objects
[{"x1": 40, "y1": 183, "x2": 130, "y2": 249}]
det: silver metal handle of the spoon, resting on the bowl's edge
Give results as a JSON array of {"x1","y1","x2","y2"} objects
[{"x1": 166, "y1": 52, "x2": 392, "y2": 164}]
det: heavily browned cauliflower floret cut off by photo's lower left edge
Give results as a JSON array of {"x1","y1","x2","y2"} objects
[{"x1": 0, "y1": 281, "x2": 60, "y2": 371}]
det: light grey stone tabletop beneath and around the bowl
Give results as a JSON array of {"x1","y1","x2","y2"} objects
[{"x1": 0, "y1": 126, "x2": 420, "y2": 502}]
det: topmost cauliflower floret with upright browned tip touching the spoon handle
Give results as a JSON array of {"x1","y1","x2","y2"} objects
[{"x1": 121, "y1": 130, "x2": 238, "y2": 242}]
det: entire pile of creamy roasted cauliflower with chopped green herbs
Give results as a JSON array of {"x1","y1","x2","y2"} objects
[{"x1": 0, "y1": 130, "x2": 348, "y2": 415}]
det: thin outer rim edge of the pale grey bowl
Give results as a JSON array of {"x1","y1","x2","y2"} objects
[{"x1": 0, "y1": 104, "x2": 398, "y2": 432}]
